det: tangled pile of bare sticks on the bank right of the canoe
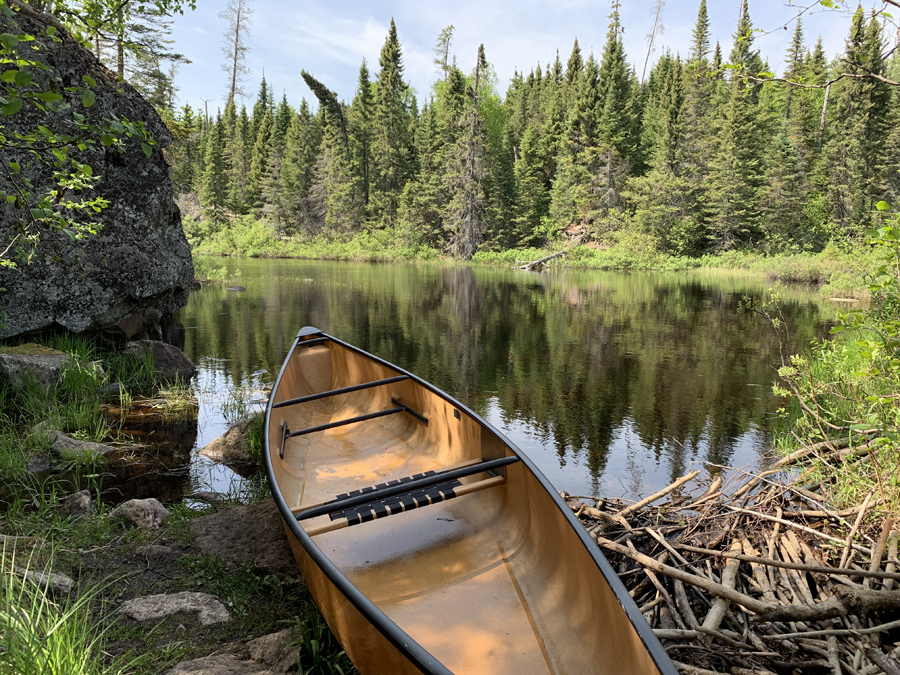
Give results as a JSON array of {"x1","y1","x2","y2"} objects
[{"x1": 563, "y1": 456, "x2": 900, "y2": 675}]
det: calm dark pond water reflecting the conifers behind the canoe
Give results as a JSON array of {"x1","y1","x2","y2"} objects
[{"x1": 170, "y1": 260, "x2": 836, "y2": 497}]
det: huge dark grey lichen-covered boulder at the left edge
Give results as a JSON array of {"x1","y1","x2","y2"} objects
[{"x1": 0, "y1": 3, "x2": 194, "y2": 338}]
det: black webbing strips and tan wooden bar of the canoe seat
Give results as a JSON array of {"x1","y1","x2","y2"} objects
[{"x1": 306, "y1": 472, "x2": 506, "y2": 537}]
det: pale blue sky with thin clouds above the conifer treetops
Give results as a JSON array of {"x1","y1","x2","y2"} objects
[{"x1": 165, "y1": 0, "x2": 884, "y2": 113}]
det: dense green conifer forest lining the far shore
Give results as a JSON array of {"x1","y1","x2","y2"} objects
[{"x1": 167, "y1": 0, "x2": 900, "y2": 259}]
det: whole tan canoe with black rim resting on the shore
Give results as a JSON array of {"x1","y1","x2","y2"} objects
[{"x1": 264, "y1": 327, "x2": 677, "y2": 675}]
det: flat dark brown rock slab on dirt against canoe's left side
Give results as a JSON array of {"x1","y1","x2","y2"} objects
[{"x1": 190, "y1": 499, "x2": 300, "y2": 577}]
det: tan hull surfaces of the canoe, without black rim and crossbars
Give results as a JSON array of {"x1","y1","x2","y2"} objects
[{"x1": 268, "y1": 342, "x2": 659, "y2": 675}]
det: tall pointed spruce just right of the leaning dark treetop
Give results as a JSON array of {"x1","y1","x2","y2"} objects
[{"x1": 369, "y1": 19, "x2": 411, "y2": 227}]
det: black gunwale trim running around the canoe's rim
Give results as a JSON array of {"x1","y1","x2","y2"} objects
[{"x1": 263, "y1": 326, "x2": 678, "y2": 675}]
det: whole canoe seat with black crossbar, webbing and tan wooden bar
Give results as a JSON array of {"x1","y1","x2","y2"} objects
[{"x1": 295, "y1": 456, "x2": 519, "y2": 536}]
